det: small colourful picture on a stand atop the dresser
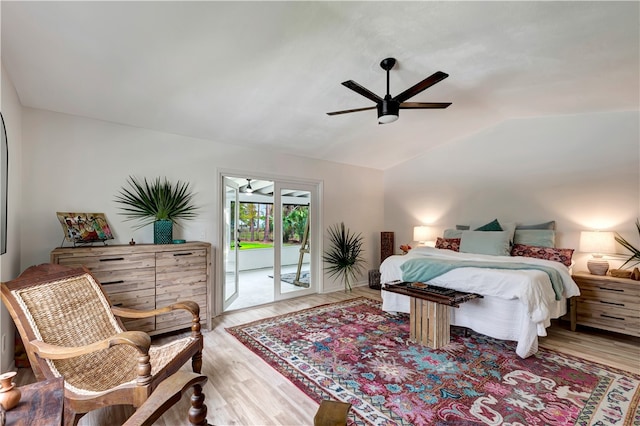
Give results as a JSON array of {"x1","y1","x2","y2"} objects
[{"x1": 56, "y1": 212, "x2": 113, "y2": 245}]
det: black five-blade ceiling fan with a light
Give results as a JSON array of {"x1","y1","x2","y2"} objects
[{"x1": 327, "y1": 58, "x2": 451, "y2": 124}]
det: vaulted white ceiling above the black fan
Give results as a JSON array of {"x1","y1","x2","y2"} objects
[{"x1": 0, "y1": 1, "x2": 640, "y2": 169}]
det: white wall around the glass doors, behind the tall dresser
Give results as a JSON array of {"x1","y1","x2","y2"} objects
[{"x1": 21, "y1": 108, "x2": 383, "y2": 291}]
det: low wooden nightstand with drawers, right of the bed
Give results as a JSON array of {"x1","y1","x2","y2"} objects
[{"x1": 571, "y1": 272, "x2": 640, "y2": 337}]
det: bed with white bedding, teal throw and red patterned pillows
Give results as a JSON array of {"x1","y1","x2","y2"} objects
[{"x1": 380, "y1": 221, "x2": 580, "y2": 358}]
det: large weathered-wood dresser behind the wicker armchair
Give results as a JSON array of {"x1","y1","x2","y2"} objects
[{"x1": 51, "y1": 242, "x2": 212, "y2": 335}]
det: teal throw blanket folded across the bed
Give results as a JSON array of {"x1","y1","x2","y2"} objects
[{"x1": 400, "y1": 258, "x2": 564, "y2": 300}]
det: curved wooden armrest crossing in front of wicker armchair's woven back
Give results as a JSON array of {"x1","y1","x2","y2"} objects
[{"x1": 29, "y1": 331, "x2": 151, "y2": 359}]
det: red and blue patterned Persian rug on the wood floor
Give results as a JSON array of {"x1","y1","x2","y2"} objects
[{"x1": 227, "y1": 297, "x2": 640, "y2": 426}]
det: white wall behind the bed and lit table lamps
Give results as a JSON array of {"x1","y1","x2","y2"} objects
[{"x1": 384, "y1": 111, "x2": 640, "y2": 269}]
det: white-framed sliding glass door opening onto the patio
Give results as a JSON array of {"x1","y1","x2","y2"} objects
[{"x1": 216, "y1": 172, "x2": 320, "y2": 312}]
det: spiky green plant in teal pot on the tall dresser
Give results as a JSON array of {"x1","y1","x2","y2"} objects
[{"x1": 116, "y1": 176, "x2": 197, "y2": 244}]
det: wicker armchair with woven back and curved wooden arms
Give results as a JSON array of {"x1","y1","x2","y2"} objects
[{"x1": 2, "y1": 264, "x2": 206, "y2": 425}]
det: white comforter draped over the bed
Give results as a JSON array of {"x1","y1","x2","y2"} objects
[{"x1": 380, "y1": 247, "x2": 580, "y2": 358}]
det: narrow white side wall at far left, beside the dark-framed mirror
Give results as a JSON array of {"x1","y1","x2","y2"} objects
[{"x1": 0, "y1": 67, "x2": 22, "y2": 372}]
